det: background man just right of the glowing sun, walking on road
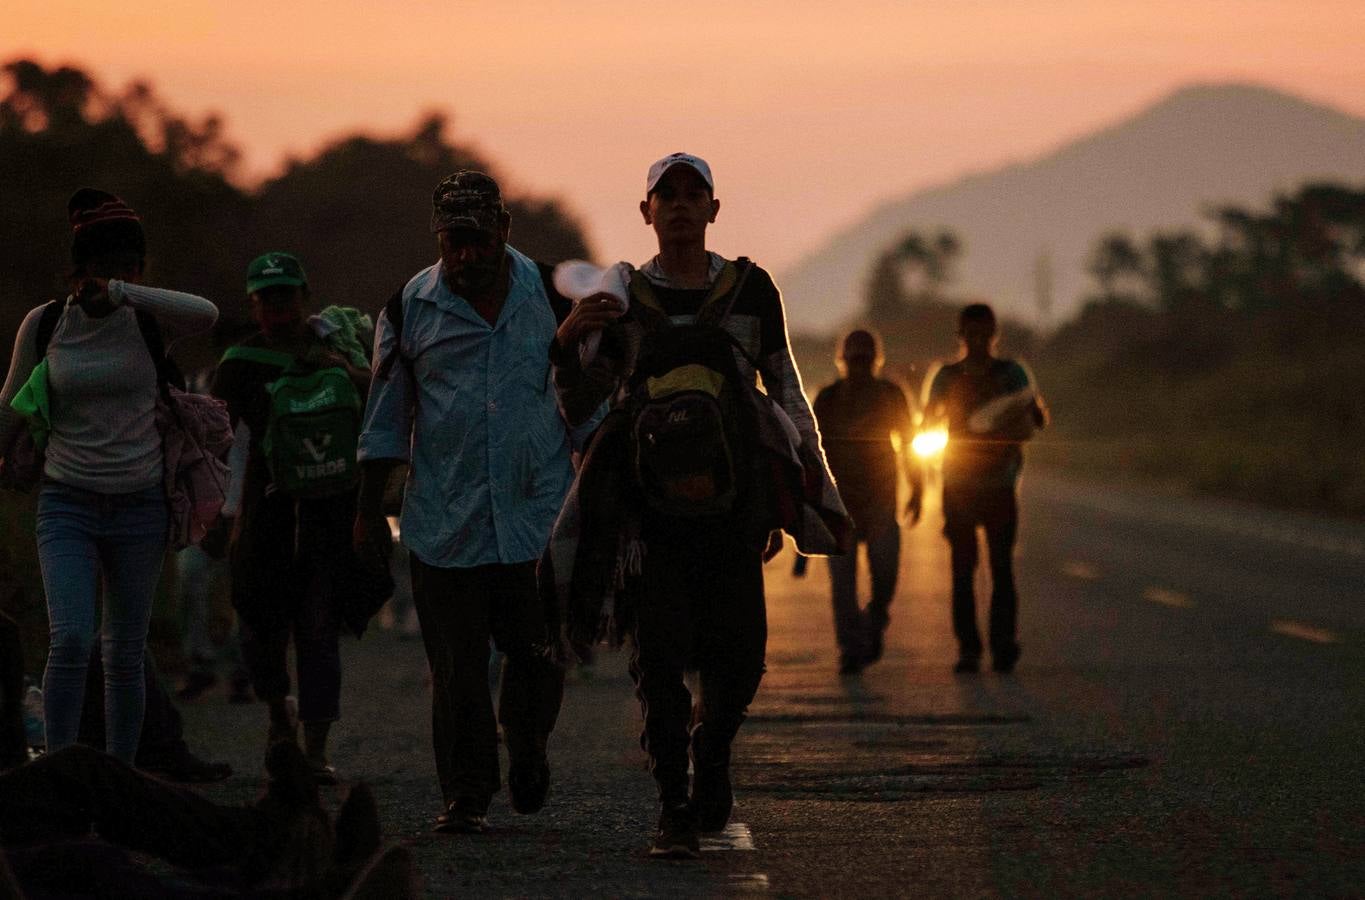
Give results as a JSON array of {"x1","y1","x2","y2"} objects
[{"x1": 924, "y1": 303, "x2": 1047, "y2": 673}]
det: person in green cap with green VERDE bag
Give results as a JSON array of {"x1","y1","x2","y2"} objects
[{"x1": 212, "y1": 253, "x2": 370, "y2": 784}]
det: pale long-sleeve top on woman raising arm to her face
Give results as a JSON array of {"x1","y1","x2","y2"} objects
[{"x1": 0, "y1": 280, "x2": 218, "y2": 494}]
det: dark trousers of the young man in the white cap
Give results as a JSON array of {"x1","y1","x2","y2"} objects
[{"x1": 631, "y1": 529, "x2": 767, "y2": 804}]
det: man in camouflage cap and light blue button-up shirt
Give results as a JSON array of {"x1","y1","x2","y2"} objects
[{"x1": 354, "y1": 171, "x2": 595, "y2": 833}]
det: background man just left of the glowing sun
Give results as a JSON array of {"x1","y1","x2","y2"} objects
[{"x1": 815, "y1": 329, "x2": 924, "y2": 675}]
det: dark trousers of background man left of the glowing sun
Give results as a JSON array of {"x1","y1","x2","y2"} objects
[{"x1": 829, "y1": 511, "x2": 901, "y2": 657}]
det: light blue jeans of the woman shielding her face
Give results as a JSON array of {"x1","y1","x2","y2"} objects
[{"x1": 37, "y1": 482, "x2": 168, "y2": 765}]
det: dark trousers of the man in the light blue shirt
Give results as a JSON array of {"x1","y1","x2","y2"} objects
[{"x1": 412, "y1": 556, "x2": 564, "y2": 808}]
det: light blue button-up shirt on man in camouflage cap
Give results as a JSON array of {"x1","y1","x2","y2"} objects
[{"x1": 359, "y1": 247, "x2": 599, "y2": 568}]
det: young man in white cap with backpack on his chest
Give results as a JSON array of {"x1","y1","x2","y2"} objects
[{"x1": 542, "y1": 153, "x2": 842, "y2": 858}]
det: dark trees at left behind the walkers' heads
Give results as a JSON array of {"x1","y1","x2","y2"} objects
[{"x1": 0, "y1": 59, "x2": 591, "y2": 368}]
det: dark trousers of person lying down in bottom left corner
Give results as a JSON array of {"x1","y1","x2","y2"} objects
[{"x1": 0, "y1": 744, "x2": 260, "y2": 869}]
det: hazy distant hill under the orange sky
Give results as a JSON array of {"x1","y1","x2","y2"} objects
[{"x1": 778, "y1": 85, "x2": 1365, "y2": 332}]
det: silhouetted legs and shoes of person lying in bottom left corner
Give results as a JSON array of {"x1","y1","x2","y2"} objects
[{"x1": 0, "y1": 742, "x2": 415, "y2": 897}]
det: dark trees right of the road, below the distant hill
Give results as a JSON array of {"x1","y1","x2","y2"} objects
[{"x1": 864, "y1": 183, "x2": 1365, "y2": 515}]
